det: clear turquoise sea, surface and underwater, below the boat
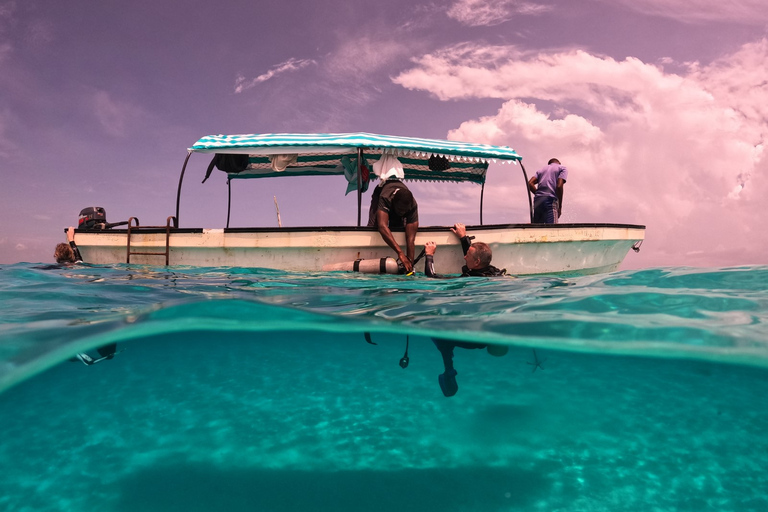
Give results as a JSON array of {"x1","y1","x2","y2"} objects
[{"x1": 0, "y1": 263, "x2": 768, "y2": 512}]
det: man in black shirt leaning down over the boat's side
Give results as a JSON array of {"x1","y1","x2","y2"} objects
[{"x1": 368, "y1": 155, "x2": 419, "y2": 273}]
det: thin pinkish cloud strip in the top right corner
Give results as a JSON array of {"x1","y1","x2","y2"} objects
[{"x1": 602, "y1": 0, "x2": 768, "y2": 25}]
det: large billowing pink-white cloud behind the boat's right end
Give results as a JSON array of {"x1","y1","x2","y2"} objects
[{"x1": 394, "y1": 40, "x2": 768, "y2": 265}]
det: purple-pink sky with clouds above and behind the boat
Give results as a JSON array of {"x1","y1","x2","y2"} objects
[{"x1": 0, "y1": 0, "x2": 768, "y2": 269}]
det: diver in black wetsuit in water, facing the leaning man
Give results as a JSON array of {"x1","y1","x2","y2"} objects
[{"x1": 424, "y1": 223, "x2": 508, "y2": 396}]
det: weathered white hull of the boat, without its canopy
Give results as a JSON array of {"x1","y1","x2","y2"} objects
[{"x1": 76, "y1": 224, "x2": 645, "y2": 275}]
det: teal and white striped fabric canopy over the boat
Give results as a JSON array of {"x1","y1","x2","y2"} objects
[{"x1": 189, "y1": 133, "x2": 522, "y2": 183}]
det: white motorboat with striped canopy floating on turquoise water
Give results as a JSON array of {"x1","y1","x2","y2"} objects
[{"x1": 76, "y1": 133, "x2": 645, "y2": 275}]
